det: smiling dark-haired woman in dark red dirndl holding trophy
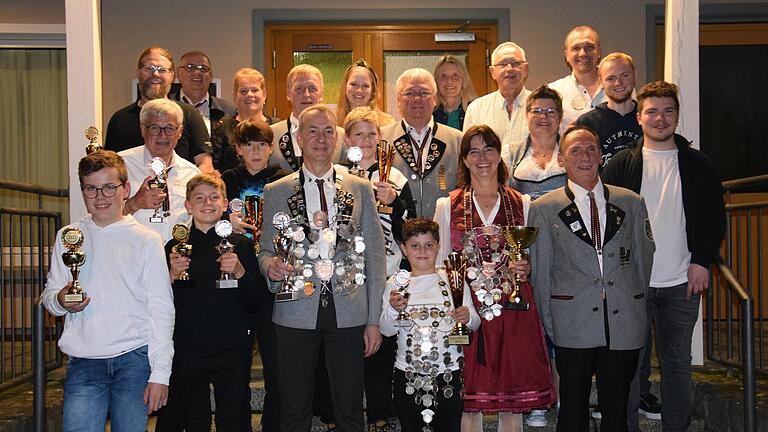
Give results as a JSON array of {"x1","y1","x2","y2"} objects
[{"x1": 435, "y1": 125, "x2": 555, "y2": 431}]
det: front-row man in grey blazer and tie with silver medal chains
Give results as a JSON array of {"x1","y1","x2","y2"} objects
[{"x1": 259, "y1": 105, "x2": 386, "y2": 432}]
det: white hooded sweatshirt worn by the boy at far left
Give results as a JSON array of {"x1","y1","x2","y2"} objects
[{"x1": 41, "y1": 215, "x2": 175, "y2": 385}]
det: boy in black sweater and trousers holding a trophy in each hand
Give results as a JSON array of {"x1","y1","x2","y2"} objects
[{"x1": 165, "y1": 174, "x2": 266, "y2": 430}]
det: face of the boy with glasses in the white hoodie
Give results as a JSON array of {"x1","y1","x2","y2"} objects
[{"x1": 80, "y1": 167, "x2": 131, "y2": 227}]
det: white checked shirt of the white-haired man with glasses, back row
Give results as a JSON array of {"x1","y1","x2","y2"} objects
[{"x1": 464, "y1": 88, "x2": 531, "y2": 156}]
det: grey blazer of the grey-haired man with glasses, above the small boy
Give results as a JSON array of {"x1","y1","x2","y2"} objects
[{"x1": 381, "y1": 121, "x2": 462, "y2": 219}]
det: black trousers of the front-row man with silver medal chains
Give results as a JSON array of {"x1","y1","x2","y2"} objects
[{"x1": 275, "y1": 296, "x2": 365, "y2": 432}]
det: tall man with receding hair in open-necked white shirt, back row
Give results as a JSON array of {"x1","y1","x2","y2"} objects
[{"x1": 549, "y1": 26, "x2": 605, "y2": 133}]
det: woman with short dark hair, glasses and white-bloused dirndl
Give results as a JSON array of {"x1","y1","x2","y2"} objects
[{"x1": 501, "y1": 85, "x2": 568, "y2": 200}]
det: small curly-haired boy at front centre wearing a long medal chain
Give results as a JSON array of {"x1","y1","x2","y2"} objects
[{"x1": 379, "y1": 218, "x2": 480, "y2": 432}]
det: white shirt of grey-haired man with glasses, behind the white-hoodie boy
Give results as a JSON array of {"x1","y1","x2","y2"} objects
[{"x1": 118, "y1": 146, "x2": 200, "y2": 243}]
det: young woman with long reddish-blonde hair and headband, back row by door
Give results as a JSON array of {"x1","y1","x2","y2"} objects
[{"x1": 336, "y1": 59, "x2": 395, "y2": 126}]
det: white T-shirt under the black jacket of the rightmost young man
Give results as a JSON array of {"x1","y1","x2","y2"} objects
[{"x1": 640, "y1": 147, "x2": 691, "y2": 288}]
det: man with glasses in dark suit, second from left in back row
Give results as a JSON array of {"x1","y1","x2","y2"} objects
[{"x1": 170, "y1": 51, "x2": 236, "y2": 133}]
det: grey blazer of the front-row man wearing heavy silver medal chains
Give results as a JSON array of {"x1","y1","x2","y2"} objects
[{"x1": 259, "y1": 165, "x2": 387, "y2": 329}]
